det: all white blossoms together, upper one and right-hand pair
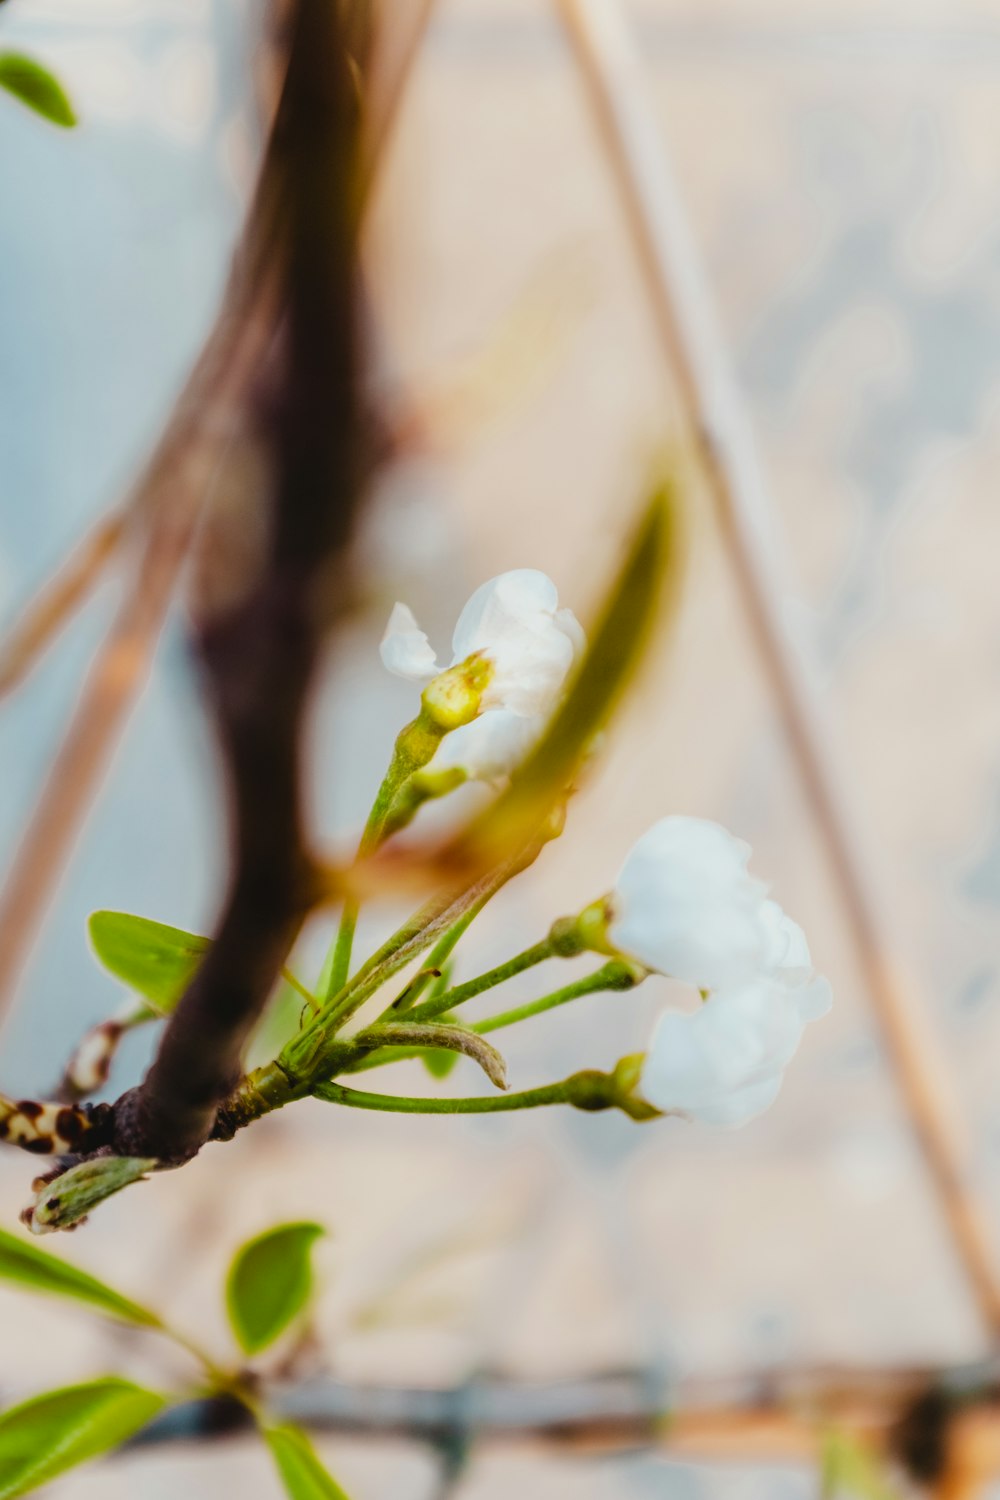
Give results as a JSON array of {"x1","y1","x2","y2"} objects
[{"x1": 381, "y1": 569, "x2": 831, "y2": 1125}]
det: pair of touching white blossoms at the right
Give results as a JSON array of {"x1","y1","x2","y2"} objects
[{"x1": 606, "y1": 818, "x2": 831, "y2": 1125}]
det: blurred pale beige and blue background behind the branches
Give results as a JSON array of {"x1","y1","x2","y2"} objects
[{"x1": 0, "y1": 0, "x2": 1000, "y2": 1500}]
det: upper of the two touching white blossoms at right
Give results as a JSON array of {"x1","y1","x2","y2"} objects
[{"x1": 607, "y1": 818, "x2": 784, "y2": 990}]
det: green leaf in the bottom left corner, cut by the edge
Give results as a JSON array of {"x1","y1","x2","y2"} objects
[{"x1": 0, "y1": 1377, "x2": 166, "y2": 1500}]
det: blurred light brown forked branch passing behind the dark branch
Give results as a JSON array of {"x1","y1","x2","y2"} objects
[{"x1": 0, "y1": 5, "x2": 430, "y2": 1044}]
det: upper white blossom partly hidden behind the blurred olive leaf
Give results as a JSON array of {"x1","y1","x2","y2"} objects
[{"x1": 381, "y1": 569, "x2": 585, "y2": 782}]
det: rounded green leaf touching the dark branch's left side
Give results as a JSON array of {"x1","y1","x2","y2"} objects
[{"x1": 87, "y1": 912, "x2": 211, "y2": 1014}]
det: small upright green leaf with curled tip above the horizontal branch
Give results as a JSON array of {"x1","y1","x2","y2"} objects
[{"x1": 226, "y1": 1223, "x2": 325, "y2": 1355}]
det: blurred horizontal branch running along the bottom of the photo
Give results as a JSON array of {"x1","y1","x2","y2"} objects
[{"x1": 119, "y1": 1365, "x2": 1000, "y2": 1496}]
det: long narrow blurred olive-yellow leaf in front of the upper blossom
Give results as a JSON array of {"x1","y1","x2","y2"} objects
[{"x1": 450, "y1": 476, "x2": 682, "y2": 872}]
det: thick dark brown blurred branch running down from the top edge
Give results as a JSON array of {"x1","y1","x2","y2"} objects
[{"x1": 112, "y1": 0, "x2": 361, "y2": 1163}]
